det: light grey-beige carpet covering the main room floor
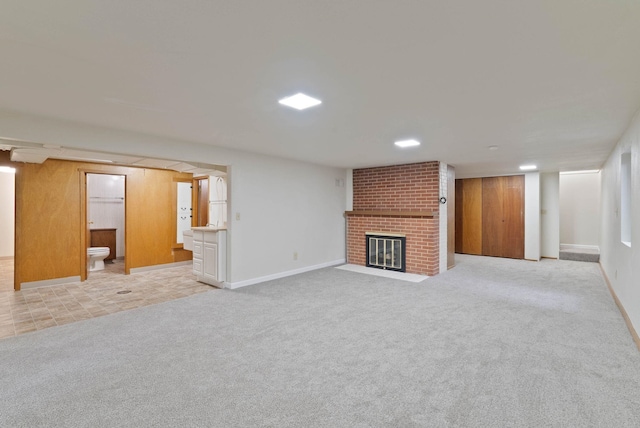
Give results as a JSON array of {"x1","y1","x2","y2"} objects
[{"x1": 0, "y1": 256, "x2": 640, "y2": 428}]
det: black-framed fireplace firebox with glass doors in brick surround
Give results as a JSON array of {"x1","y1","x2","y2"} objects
[{"x1": 365, "y1": 232, "x2": 407, "y2": 272}]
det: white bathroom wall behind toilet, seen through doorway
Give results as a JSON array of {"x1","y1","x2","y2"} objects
[{"x1": 87, "y1": 174, "x2": 125, "y2": 258}]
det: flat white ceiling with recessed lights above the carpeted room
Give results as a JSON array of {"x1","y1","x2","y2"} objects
[{"x1": 0, "y1": 0, "x2": 640, "y2": 176}]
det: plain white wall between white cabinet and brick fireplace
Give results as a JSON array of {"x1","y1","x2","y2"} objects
[{"x1": 229, "y1": 156, "x2": 346, "y2": 285}]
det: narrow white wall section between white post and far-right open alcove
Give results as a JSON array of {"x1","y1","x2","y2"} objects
[{"x1": 540, "y1": 172, "x2": 560, "y2": 259}]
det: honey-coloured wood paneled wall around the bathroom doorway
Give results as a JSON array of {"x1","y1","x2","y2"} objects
[{"x1": 12, "y1": 159, "x2": 191, "y2": 289}]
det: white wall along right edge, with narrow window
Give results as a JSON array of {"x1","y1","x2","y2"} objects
[{"x1": 600, "y1": 109, "x2": 640, "y2": 338}]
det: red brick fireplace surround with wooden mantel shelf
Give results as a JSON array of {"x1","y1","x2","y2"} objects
[{"x1": 346, "y1": 162, "x2": 440, "y2": 276}]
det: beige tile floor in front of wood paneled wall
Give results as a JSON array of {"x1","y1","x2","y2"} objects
[{"x1": 0, "y1": 259, "x2": 216, "y2": 339}]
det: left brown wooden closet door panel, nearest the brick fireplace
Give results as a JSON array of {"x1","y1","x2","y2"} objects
[{"x1": 455, "y1": 178, "x2": 483, "y2": 255}]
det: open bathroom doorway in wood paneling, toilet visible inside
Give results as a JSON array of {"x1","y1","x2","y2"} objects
[{"x1": 86, "y1": 173, "x2": 126, "y2": 276}]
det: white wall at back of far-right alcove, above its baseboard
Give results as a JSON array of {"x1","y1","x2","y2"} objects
[{"x1": 560, "y1": 172, "x2": 601, "y2": 247}]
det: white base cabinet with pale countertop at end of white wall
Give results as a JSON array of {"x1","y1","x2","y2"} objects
[{"x1": 193, "y1": 227, "x2": 227, "y2": 288}]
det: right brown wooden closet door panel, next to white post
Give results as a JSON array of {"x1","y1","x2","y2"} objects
[{"x1": 482, "y1": 175, "x2": 524, "y2": 259}]
